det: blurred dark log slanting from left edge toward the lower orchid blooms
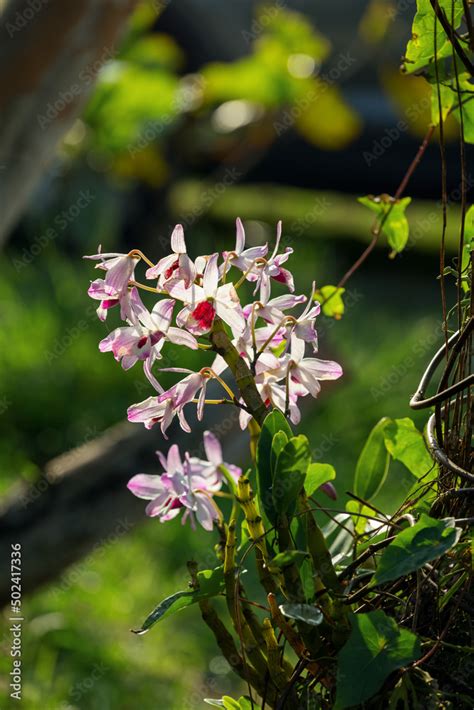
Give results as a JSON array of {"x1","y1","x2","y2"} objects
[{"x1": 0, "y1": 422, "x2": 152, "y2": 606}]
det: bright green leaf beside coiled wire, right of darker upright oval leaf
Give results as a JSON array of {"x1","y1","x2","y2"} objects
[{"x1": 383, "y1": 417, "x2": 434, "y2": 478}]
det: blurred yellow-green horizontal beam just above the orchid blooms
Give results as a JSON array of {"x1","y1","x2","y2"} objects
[{"x1": 168, "y1": 182, "x2": 461, "y2": 254}]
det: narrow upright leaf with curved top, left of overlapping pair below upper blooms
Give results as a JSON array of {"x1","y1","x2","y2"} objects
[{"x1": 257, "y1": 409, "x2": 293, "y2": 524}]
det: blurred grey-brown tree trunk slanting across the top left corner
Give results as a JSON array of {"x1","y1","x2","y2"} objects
[{"x1": 0, "y1": 0, "x2": 138, "y2": 245}]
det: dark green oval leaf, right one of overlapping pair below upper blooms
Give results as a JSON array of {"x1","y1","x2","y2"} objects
[{"x1": 272, "y1": 434, "x2": 311, "y2": 515}]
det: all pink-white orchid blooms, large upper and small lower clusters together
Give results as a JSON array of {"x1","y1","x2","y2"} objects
[{"x1": 85, "y1": 219, "x2": 342, "y2": 530}]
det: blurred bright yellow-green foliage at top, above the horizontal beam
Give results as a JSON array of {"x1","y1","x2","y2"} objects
[{"x1": 65, "y1": 3, "x2": 360, "y2": 186}]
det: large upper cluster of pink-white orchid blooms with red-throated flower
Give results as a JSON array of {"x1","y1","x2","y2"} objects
[{"x1": 86, "y1": 219, "x2": 342, "y2": 437}]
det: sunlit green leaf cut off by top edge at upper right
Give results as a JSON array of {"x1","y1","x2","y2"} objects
[{"x1": 403, "y1": 0, "x2": 463, "y2": 74}]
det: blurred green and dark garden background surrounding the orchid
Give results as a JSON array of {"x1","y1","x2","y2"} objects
[{"x1": 0, "y1": 0, "x2": 457, "y2": 710}]
